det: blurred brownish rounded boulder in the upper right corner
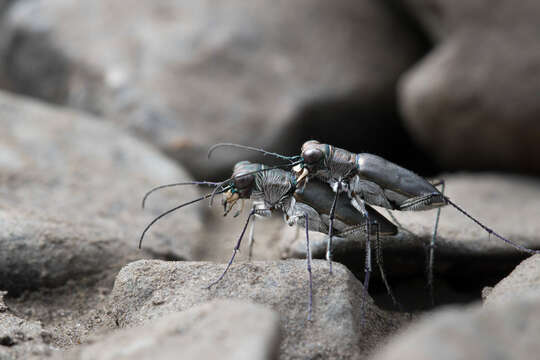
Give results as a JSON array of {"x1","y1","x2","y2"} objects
[{"x1": 399, "y1": 0, "x2": 540, "y2": 174}]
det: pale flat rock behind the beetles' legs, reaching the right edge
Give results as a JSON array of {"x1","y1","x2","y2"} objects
[{"x1": 280, "y1": 174, "x2": 540, "y2": 274}]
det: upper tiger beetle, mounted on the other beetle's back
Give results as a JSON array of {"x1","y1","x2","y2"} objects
[{"x1": 208, "y1": 140, "x2": 540, "y2": 304}]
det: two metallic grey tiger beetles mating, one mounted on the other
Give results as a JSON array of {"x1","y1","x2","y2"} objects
[{"x1": 141, "y1": 140, "x2": 540, "y2": 316}]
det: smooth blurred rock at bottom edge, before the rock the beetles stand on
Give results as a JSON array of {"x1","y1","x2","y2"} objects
[{"x1": 57, "y1": 300, "x2": 279, "y2": 360}]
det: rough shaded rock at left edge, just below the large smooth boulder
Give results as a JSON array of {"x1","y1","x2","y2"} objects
[{"x1": 0, "y1": 209, "x2": 143, "y2": 293}]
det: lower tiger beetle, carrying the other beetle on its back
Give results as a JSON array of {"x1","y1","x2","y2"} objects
[{"x1": 139, "y1": 161, "x2": 400, "y2": 319}]
